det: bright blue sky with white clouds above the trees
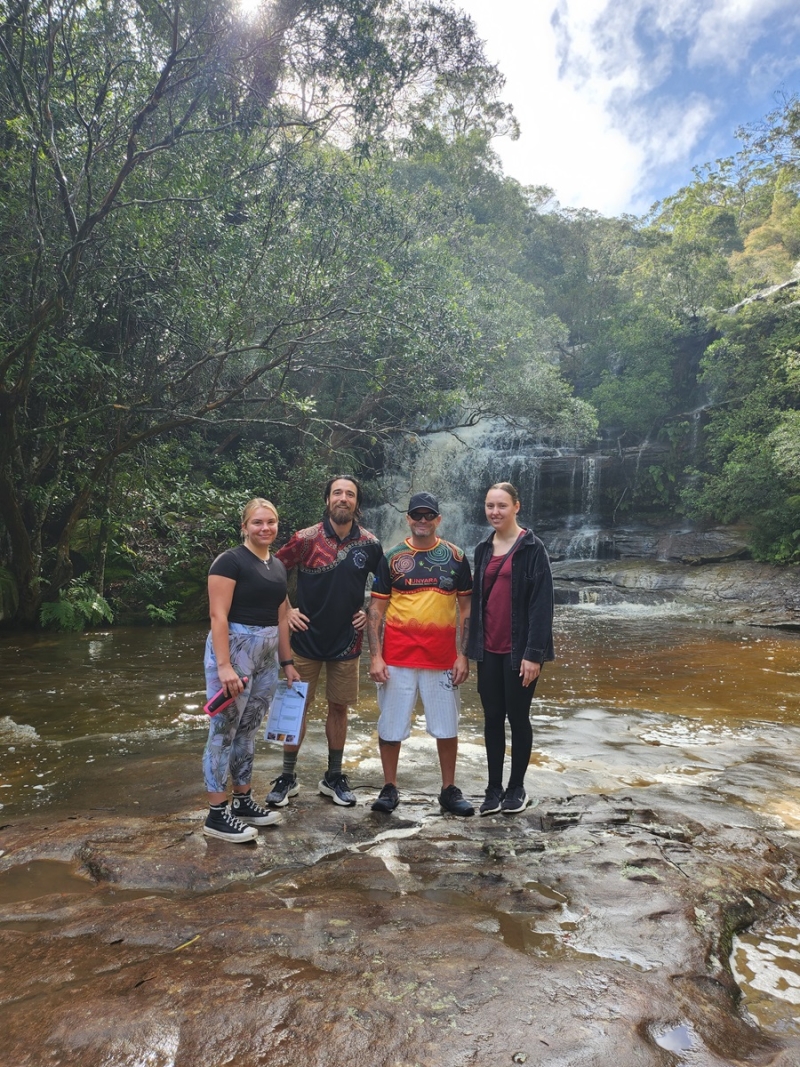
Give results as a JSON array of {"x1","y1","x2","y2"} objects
[{"x1": 455, "y1": 0, "x2": 800, "y2": 216}]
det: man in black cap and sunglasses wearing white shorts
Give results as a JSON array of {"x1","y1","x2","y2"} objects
[{"x1": 367, "y1": 493, "x2": 475, "y2": 815}]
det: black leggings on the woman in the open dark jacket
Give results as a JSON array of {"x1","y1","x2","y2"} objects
[{"x1": 478, "y1": 652, "x2": 537, "y2": 789}]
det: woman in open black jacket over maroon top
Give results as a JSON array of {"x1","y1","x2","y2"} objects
[{"x1": 467, "y1": 481, "x2": 555, "y2": 815}]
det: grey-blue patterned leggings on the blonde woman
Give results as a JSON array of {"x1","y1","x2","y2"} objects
[{"x1": 203, "y1": 622, "x2": 278, "y2": 793}]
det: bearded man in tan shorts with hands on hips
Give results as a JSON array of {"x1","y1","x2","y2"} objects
[{"x1": 267, "y1": 475, "x2": 383, "y2": 808}]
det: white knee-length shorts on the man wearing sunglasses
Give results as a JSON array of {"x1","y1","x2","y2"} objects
[{"x1": 378, "y1": 667, "x2": 461, "y2": 742}]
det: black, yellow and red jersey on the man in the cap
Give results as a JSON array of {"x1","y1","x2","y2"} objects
[{"x1": 372, "y1": 540, "x2": 473, "y2": 670}]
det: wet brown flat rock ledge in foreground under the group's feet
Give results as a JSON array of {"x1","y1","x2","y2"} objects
[{"x1": 0, "y1": 793, "x2": 800, "y2": 1067}]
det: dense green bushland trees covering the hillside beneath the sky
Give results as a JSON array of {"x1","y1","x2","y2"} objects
[{"x1": 7, "y1": 0, "x2": 800, "y2": 610}]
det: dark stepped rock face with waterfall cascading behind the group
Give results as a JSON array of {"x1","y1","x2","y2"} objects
[{"x1": 367, "y1": 424, "x2": 800, "y2": 628}]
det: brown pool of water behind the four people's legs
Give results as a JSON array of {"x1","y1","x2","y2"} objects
[{"x1": 0, "y1": 606, "x2": 800, "y2": 827}]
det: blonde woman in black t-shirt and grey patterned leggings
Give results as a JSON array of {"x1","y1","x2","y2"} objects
[{"x1": 203, "y1": 497, "x2": 300, "y2": 842}]
